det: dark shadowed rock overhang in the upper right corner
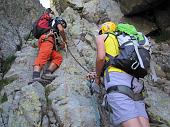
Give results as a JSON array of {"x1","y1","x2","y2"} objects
[{"x1": 117, "y1": 0, "x2": 170, "y2": 39}]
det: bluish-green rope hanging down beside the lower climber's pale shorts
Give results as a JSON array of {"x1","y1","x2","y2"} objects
[{"x1": 87, "y1": 80, "x2": 101, "y2": 127}]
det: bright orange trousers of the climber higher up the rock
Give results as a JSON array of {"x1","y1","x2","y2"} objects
[{"x1": 34, "y1": 34, "x2": 63, "y2": 67}]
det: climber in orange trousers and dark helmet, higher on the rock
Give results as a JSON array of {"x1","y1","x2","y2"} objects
[{"x1": 31, "y1": 8, "x2": 67, "y2": 82}]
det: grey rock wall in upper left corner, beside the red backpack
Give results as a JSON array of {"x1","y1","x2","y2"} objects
[{"x1": 0, "y1": 0, "x2": 43, "y2": 58}]
